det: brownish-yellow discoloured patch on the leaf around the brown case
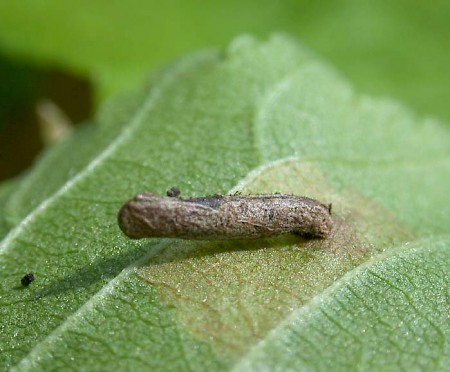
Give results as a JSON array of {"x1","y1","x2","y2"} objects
[{"x1": 138, "y1": 160, "x2": 414, "y2": 360}]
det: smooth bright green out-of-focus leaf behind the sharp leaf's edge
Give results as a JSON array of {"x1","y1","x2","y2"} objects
[{"x1": 0, "y1": 0, "x2": 450, "y2": 121}]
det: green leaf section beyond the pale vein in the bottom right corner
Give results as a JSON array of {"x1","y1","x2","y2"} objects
[{"x1": 236, "y1": 237, "x2": 450, "y2": 371}]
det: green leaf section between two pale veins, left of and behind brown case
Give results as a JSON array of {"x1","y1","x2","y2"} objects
[{"x1": 1, "y1": 36, "x2": 316, "y2": 365}]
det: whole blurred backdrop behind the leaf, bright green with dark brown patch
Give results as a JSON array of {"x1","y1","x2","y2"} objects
[{"x1": 0, "y1": 0, "x2": 450, "y2": 179}]
